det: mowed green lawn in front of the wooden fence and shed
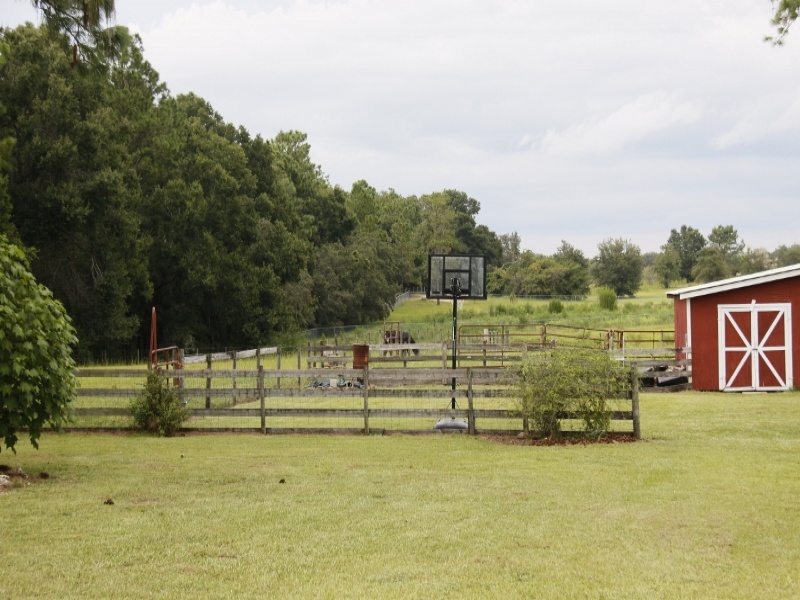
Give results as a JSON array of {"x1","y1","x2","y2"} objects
[{"x1": 0, "y1": 392, "x2": 800, "y2": 599}]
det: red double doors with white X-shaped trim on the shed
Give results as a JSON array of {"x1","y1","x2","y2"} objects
[{"x1": 717, "y1": 302, "x2": 794, "y2": 391}]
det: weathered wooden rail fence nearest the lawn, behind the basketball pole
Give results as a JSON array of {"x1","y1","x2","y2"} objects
[{"x1": 73, "y1": 366, "x2": 668, "y2": 437}]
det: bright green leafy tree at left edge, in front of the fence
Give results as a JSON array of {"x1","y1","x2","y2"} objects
[{"x1": 0, "y1": 235, "x2": 77, "y2": 451}]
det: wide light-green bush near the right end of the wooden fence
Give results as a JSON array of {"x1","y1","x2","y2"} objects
[{"x1": 517, "y1": 349, "x2": 628, "y2": 438}]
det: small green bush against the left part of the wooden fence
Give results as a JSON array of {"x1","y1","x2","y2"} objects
[{"x1": 131, "y1": 373, "x2": 191, "y2": 437}]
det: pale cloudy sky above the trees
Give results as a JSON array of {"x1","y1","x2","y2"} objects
[{"x1": 0, "y1": 0, "x2": 800, "y2": 257}]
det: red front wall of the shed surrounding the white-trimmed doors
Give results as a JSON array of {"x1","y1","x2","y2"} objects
[{"x1": 688, "y1": 277, "x2": 800, "y2": 390}]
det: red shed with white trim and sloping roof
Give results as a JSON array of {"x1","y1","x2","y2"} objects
[{"x1": 667, "y1": 264, "x2": 800, "y2": 391}]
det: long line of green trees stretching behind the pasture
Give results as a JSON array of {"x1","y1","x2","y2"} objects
[{"x1": 0, "y1": 11, "x2": 800, "y2": 357}]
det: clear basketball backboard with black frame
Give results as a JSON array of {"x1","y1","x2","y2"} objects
[{"x1": 425, "y1": 254, "x2": 486, "y2": 300}]
